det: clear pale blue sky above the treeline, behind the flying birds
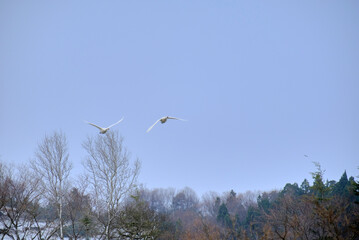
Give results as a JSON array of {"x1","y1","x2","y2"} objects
[{"x1": 0, "y1": 0, "x2": 359, "y2": 198}]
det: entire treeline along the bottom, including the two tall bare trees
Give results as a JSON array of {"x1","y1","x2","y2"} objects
[{"x1": 0, "y1": 131, "x2": 359, "y2": 240}]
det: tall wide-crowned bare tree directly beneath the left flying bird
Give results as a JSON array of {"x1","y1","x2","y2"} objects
[{"x1": 83, "y1": 131, "x2": 140, "y2": 239}]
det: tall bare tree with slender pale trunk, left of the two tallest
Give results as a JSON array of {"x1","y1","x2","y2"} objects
[{"x1": 31, "y1": 132, "x2": 72, "y2": 239}]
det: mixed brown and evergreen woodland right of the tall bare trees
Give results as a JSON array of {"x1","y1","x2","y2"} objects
[{"x1": 140, "y1": 163, "x2": 359, "y2": 240}]
